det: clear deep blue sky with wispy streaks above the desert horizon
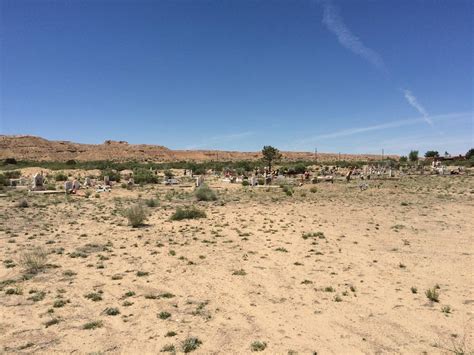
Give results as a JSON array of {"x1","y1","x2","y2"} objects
[{"x1": 0, "y1": 0, "x2": 474, "y2": 154}]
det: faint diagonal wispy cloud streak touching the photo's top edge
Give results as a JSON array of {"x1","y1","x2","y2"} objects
[{"x1": 318, "y1": 0, "x2": 386, "y2": 71}]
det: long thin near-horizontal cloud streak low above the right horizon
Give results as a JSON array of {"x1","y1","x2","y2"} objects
[{"x1": 299, "y1": 112, "x2": 473, "y2": 144}]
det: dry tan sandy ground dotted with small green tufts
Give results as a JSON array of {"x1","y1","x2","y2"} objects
[{"x1": 0, "y1": 172, "x2": 474, "y2": 354}]
